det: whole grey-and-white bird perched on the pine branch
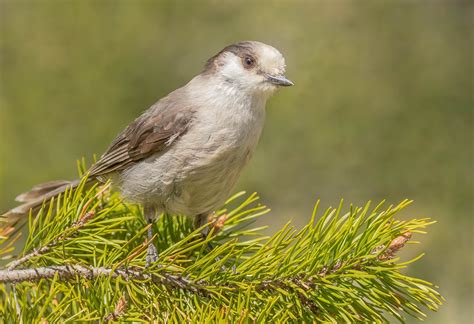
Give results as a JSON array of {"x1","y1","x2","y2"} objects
[{"x1": 3, "y1": 41, "x2": 293, "y2": 265}]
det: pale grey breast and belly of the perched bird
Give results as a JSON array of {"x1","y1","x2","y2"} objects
[{"x1": 118, "y1": 95, "x2": 265, "y2": 216}]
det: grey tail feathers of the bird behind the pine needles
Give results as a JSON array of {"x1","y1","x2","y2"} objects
[{"x1": 2, "y1": 180, "x2": 85, "y2": 222}]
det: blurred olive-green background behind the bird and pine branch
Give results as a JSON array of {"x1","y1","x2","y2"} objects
[{"x1": 0, "y1": 0, "x2": 474, "y2": 323}]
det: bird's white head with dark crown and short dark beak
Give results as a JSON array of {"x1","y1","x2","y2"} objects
[{"x1": 204, "y1": 41, "x2": 293, "y2": 95}]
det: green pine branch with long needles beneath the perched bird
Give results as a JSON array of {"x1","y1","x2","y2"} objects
[{"x1": 0, "y1": 176, "x2": 442, "y2": 323}]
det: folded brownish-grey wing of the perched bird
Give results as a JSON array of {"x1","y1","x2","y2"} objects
[{"x1": 89, "y1": 92, "x2": 194, "y2": 176}]
